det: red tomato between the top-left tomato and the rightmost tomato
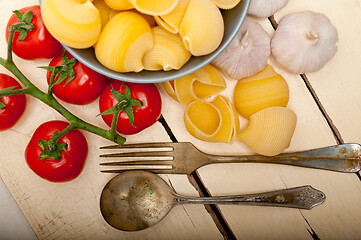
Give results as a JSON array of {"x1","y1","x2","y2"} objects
[{"x1": 47, "y1": 53, "x2": 108, "y2": 105}]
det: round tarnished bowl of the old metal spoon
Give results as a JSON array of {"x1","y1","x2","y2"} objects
[{"x1": 100, "y1": 171, "x2": 174, "y2": 231}]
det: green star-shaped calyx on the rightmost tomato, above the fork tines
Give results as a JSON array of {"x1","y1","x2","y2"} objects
[{"x1": 99, "y1": 83, "x2": 143, "y2": 127}]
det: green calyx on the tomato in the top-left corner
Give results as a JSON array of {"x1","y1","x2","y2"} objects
[{"x1": 8, "y1": 10, "x2": 34, "y2": 41}]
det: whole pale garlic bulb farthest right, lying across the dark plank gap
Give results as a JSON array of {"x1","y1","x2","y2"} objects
[{"x1": 271, "y1": 11, "x2": 338, "y2": 74}]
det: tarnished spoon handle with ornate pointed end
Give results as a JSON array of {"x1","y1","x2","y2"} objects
[{"x1": 174, "y1": 185, "x2": 326, "y2": 210}]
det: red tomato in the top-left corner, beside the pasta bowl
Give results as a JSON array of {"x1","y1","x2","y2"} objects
[{"x1": 6, "y1": 5, "x2": 63, "y2": 60}]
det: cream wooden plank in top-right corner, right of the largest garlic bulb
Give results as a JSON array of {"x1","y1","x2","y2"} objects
[{"x1": 275, "y1": 0, "x2": 361, "y2": 142}]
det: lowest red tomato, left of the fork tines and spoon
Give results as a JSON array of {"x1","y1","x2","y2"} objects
[{"x1": 25, "y1": 121, "x2": 88, "y2": 182}]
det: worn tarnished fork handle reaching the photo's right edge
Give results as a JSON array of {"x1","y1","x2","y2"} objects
[{"x1": 208, "y1": 143, "x2": 361, "y2": 172}]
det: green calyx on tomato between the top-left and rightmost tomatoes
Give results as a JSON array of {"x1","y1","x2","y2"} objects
[{"x1": 41, "y1": 51, "x2": 78, "y2": 89}]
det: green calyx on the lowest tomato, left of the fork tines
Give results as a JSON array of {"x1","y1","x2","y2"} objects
[{"x1": 38, "y1": 132, "x2": 68, "y2": 160}]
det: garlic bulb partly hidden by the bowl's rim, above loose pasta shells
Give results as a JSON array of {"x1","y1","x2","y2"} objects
[{"x1": 212, "y1": 17, "x2": 271, "y2": 79}]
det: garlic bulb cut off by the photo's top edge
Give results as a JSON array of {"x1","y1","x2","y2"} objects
[{"x1": 248, "y1": 0, "x2": 288, "y2": 17}]
